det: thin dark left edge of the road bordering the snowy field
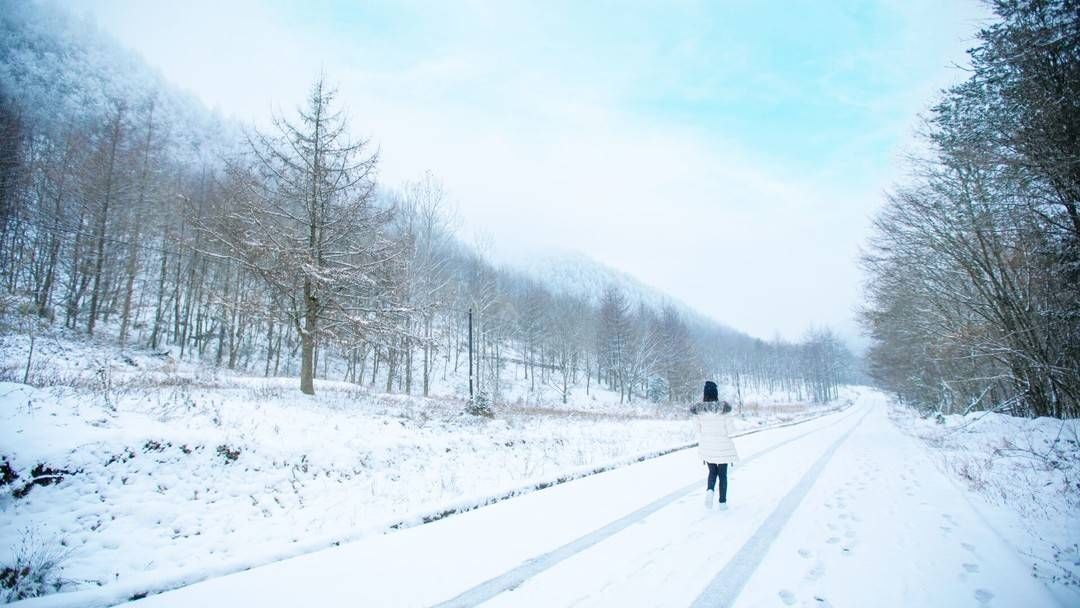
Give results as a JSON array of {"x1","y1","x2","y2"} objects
[{"x1": 10, "y1": 400, "x2": 855, "y2": 608}]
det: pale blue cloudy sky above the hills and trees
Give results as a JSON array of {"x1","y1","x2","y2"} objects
[{"x1": 73, "y1": 0, "x2": 985, "y2": 338}]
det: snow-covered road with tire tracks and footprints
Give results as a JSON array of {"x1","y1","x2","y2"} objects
[{"x1": 122, "y1": 392, "x2": 1055, "y2": 608}]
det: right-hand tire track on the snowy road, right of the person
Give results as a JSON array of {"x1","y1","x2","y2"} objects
[{"x1": 690, "y1": 409, "x2": 869, "y2": 608}]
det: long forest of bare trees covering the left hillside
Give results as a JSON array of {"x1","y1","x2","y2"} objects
[{"x1": 0, "y1": 3, "x2": 853, "y2": 403}]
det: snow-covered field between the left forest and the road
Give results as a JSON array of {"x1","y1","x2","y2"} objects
[{"x1": 0, "y1": 336, "x2": 842, "y2": 604}]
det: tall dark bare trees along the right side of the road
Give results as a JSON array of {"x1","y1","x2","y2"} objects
[{"x1": 863, "y1": 0, "x2": 1080, "y2": 417}]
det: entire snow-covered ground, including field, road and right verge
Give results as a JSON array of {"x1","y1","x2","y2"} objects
[{"x1": 0, "y1": 337, "x2": 1080, "y2": 608}]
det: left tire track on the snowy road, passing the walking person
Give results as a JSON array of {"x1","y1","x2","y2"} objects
[{"x1": 434, "y1": 403, "x2": 865, "y2": 608}]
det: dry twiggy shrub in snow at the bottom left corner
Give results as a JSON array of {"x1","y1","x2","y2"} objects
[{"x1": 0, "y1": 530, "x2": 71, "y2": 603}]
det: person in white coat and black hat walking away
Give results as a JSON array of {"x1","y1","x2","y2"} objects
[{"x1": 690, "y1": 380, "x2": 739, "y2": 511}]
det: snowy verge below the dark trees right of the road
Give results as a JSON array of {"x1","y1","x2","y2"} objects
[{"x1": 891, "y1": 407, "x2": 1080, "y2": 605}]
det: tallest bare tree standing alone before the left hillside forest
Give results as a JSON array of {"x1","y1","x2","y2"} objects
[{"x1": 204, "y1": 79, "x2": 393, "y2": 394}]
